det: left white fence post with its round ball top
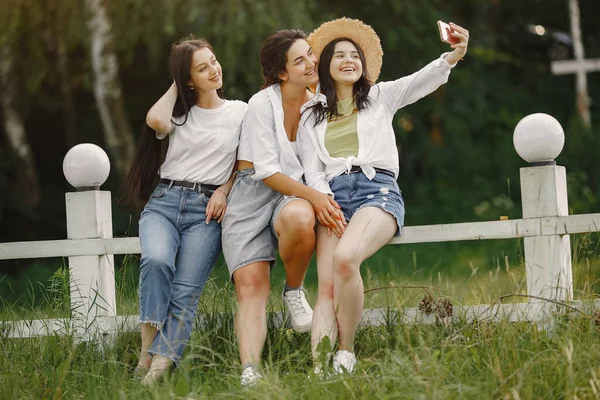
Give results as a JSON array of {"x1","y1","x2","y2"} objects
[{"x1": 63, "y1": 144, "x2": 117, "y2": 340}]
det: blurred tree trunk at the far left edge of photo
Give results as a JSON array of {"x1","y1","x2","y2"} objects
[{"x1": 0, "y1": 45, "x2": 40, "y2": 206}]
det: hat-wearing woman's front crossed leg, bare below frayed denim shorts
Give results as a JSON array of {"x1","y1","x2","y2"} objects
[{"x1": 333, "y1": 207, "x2": 398, "y2": 352}]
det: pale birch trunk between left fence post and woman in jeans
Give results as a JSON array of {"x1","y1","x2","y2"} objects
[{"x1": 85, "y1": 0, "x2": 135, "y2": 177}]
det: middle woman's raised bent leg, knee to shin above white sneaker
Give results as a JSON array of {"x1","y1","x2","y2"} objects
[{"x1": 274, "y1": 200, "x2": 316, "y2": 287}]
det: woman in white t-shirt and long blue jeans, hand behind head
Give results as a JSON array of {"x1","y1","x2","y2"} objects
[{"x1": 121, "y1": 39, "x2": 247, "y2": 384}]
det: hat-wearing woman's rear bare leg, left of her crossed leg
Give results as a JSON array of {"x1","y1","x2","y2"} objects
[{"x1": 310, "y1": 224, "x2": 340, "y2": 360}]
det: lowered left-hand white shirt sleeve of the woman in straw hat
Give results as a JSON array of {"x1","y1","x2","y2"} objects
[{"x1": 296, "y1": 115, "x2": 333, "y2": 197}]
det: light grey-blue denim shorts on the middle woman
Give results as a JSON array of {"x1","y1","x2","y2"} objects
[{"x1": 221, "y1": 168, "x2": 305, "y2": 281}]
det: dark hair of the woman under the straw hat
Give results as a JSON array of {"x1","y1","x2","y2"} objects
[{"x1": 312, "y1": 38, "x2": 373, "y2": 126}]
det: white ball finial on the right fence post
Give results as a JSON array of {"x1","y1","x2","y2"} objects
[{"x1": 513, "y1": 113, "x2": 565, "y2": 164}]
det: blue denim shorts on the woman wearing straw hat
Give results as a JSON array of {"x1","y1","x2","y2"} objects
[{"x1": 329, "y1": 172, "x2": 404, "y2": 236}]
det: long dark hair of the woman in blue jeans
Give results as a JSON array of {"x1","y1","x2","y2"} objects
[{"x1": 119, "y1": 36, "x2": 223, "y2": 210}]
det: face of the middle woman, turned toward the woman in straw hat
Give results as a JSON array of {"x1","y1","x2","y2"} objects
[{"x1": 279, "y1": 39, "x2": 319, "y2": 87}]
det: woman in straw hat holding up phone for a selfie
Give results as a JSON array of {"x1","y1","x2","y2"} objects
[{"x1": 298, "y1": 18, "x2": 469, "y2": 374}]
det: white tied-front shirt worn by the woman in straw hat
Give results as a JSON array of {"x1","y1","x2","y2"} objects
[{"x1": 297, "y1": 53, "x2": 454, "y2": 194}]
